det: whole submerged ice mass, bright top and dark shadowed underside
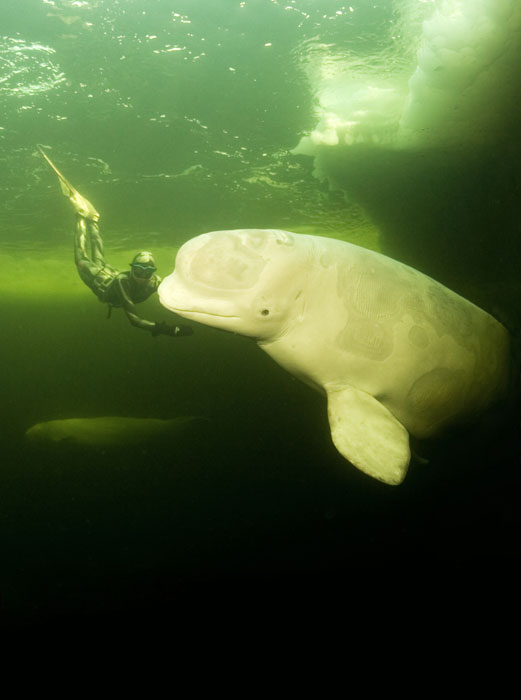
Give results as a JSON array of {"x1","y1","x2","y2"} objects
[{"x1": 293, "y1": 0, "x2": 521, "y2": 334}]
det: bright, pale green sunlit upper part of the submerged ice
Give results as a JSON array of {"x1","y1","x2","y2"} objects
[{"x1": 296, "y1": 0, "x2": 521, "y2": 155}]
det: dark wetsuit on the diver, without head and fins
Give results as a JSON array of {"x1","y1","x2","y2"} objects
[{"x1": 74, "y1": 215, "x2": 187, "y2": 336}]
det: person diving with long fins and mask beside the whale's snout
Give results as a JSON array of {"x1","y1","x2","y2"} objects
[{"x1": 38, "y1": 146, "x2": 193, "y2": 336}]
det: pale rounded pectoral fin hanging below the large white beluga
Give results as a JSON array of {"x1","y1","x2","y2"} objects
[{"x1": 327, "y1": 386, "x2": 411, "y2": 485}]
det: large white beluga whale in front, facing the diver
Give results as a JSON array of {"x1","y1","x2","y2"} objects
[{"x1": 159, "y1": 229, "x2": 510, "y2": 484}]
